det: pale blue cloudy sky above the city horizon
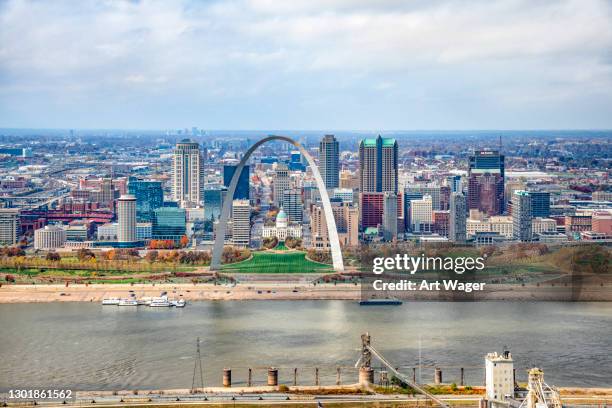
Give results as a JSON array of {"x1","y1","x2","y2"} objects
[{"x1": 0, "y1": 0, "x2": 612, "y2": 130}]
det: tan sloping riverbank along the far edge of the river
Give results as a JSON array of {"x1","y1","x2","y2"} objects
[{"x1": 0, "y1": 275, "x2": 612, "y2": 304}]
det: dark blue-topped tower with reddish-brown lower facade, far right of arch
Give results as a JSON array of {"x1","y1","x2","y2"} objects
[{"x1": 468, "y1": 150, "x2": 505, "y2": 216}]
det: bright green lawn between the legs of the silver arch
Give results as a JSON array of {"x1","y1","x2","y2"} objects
[{"x1": 222, "y1": 251, "x2": 331, "y2": 273}]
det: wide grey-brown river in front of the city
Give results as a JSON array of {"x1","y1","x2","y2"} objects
[{"x1": 0, "y1": 301, "x2": 612, "y2": 392}]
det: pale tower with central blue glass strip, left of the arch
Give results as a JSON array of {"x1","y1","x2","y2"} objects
[{"x1": 172, "y1": 139, "x2": 204, "y2": 205}]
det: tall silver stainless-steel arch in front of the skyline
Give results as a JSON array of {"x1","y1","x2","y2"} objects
[{"x1": 210, "y1": 136, "x2": 344, "y2": 272}]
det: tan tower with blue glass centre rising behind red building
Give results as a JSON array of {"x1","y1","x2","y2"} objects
[{"x1": 359, "y1": 136, "x2": 398, "y2": 194}]
